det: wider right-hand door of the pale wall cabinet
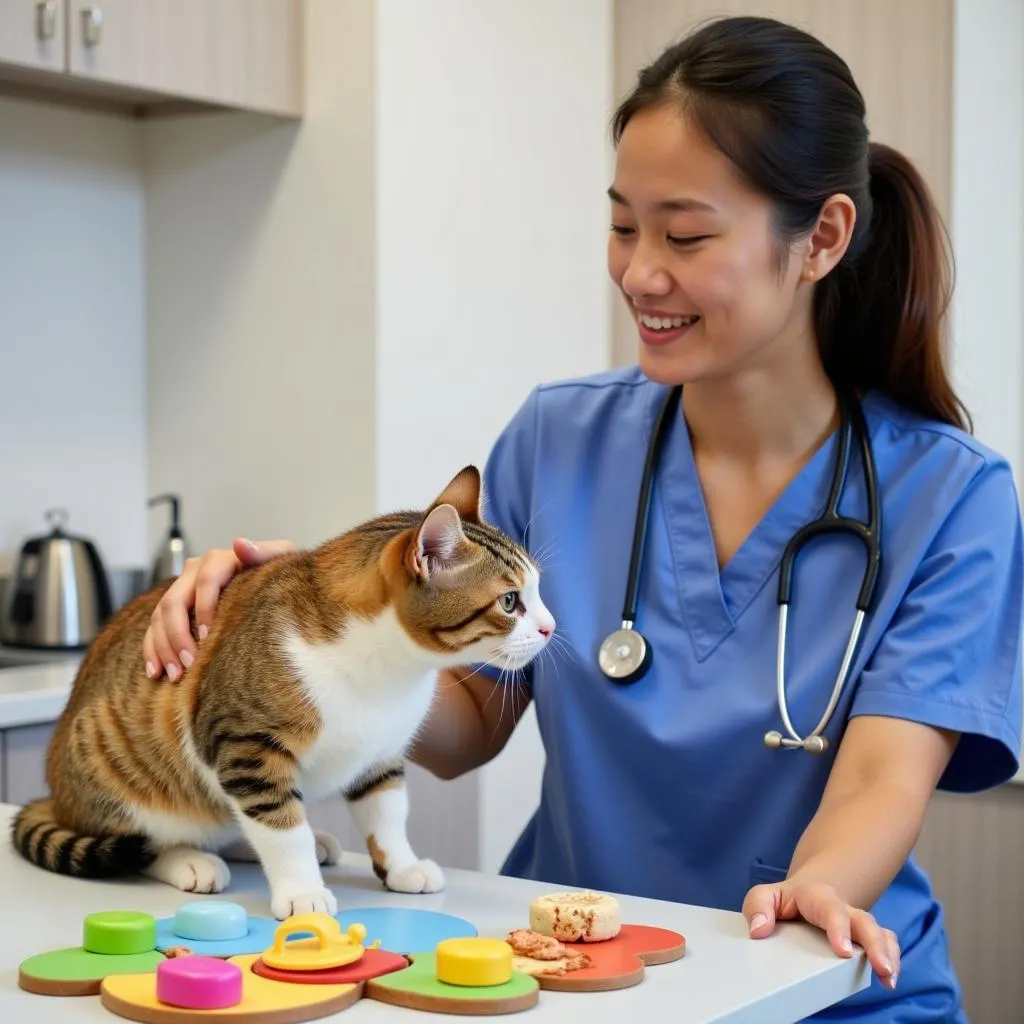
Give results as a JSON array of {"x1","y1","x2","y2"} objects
[{"x1": 68, "y1": 0, "x2": 302, "y2": 116}]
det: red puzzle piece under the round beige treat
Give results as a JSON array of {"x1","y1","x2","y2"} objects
[{"x1": 537, "y1": 925, "x2": 686, "y2": 992}]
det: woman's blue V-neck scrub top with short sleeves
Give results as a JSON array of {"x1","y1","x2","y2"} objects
[{"x1": 484, "y1": 367, "x2": 1022, "y2": 1024}]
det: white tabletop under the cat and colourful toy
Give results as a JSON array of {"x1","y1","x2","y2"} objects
[{"x1": 0, "y1": 805, "x2": 870, "y2": 1024}]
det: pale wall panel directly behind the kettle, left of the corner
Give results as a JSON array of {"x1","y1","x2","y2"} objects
[{"x1": 0, "y1": 98, "x2": 148, "y2": 574}]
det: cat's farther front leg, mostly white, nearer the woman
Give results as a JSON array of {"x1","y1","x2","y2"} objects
[{"x1": 345, "y1": 762, "x2": 444, "y2": 893}]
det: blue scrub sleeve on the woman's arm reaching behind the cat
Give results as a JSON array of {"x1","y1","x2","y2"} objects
[{"x1": 475, "y1": 388, "x2": 539, "y2": 687}]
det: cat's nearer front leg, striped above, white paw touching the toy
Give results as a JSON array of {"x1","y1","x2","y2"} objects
[{"x1": 214, "y1": 733, "x2": 338, "y2": 920}]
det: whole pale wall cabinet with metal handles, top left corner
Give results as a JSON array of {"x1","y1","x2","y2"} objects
[{"x1": 0, "y1": 0, "x2": 303, "y2": 118}]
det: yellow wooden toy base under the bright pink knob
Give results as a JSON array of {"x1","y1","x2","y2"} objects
[{"x1": 99, "y1": 955, "x2": 362, "y2": 1024}]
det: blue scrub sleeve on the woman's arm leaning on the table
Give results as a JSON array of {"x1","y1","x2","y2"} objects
[{"x1": 850, "y1": 462, "x2": 1024, "y2": 793}]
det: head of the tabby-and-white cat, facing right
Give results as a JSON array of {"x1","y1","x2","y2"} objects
[{"x1": 389, "y1": 466, "x2": 555, "y2": 669}]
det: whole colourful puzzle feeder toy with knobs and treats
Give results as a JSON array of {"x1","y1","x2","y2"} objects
[{"x1": 18, "y1": 892, "x2": 685, "y2": 1024}]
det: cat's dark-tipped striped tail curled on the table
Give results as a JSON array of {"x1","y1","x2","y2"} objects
[{"x1": 11, "y1": 800, "x2": 157, "y2": 879}]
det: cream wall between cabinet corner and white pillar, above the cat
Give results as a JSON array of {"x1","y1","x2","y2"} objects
[{"x1": 143, "y1": 0, "x2": 375, "y2": 551}]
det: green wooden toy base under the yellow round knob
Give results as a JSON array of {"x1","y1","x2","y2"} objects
[{"x1": 366, "y1": 953, "x2": 540, "y2": 1016}]
